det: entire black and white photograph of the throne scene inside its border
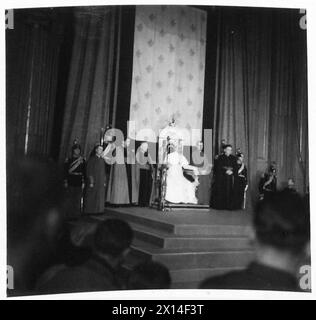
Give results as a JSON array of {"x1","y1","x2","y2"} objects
[{"x1": 3, "y1": 1, "x2": 313, "y2": 300}]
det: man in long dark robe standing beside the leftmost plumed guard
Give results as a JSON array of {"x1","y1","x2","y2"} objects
[{"x1": 84, "y1": 144, "x2": 106, "y2": 214}]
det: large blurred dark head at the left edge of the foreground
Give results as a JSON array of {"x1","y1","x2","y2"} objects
[{"x1": 7, "y1": 157, "x2": 64, "y2": 293}]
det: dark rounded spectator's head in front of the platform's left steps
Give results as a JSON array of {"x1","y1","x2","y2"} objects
[{"x1": 94, "y1": 219, "x2": 133, "y2": 267}]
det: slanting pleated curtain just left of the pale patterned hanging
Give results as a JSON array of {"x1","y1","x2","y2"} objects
[{"x1": 60, "y1": 6, "x2": 120, "y2": 159}]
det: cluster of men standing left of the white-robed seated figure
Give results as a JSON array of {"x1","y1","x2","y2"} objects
[{"x1": 64, "y1": 136, "x2": 153, "y2": 216}]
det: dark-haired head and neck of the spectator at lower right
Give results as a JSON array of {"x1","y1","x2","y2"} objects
[{"x1": 254, "y1": 191, "x2": 310, "y2": 272}]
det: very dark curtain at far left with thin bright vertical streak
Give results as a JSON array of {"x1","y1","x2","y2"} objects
[{"x1": 6, "y1": 9, "x2": 63, "y2": 159}]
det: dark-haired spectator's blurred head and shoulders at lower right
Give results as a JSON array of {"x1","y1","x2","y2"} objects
[{"x1": 200, "y1": 190, "x2": 310, "y2": 291}]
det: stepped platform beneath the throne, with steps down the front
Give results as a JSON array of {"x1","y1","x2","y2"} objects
[{"x1": 97, "y1": 207, "x2": 253, "y2": 289}]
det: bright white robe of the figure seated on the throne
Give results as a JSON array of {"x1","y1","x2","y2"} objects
[{"x1": 165, "y1": 151, "x2": 197, "y2": 203}]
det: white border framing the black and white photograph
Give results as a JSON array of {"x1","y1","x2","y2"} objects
[{"x1": 0, "y1": 0, "x2": 316, "y2": 305}]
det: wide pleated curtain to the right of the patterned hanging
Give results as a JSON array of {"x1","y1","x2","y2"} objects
[{"x1": 215, "y1": 8, "x2": 308, "y2": 204}]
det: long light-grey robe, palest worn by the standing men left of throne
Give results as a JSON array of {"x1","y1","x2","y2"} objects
[{"x1": 106, "y1": 143, "x2": 130, "y2": 205}]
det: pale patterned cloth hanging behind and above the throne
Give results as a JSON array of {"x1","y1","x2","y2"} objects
[{"x1": 129, "y1": 6, "x2": 207, "y2": 144}]
